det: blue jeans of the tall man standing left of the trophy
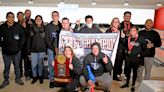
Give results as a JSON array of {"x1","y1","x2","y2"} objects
[{"x1": 47, "y1": 49, "x2": 55, "y2": 82}]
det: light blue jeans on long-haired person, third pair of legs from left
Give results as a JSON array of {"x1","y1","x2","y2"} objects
[{"x1": 31, "y1": 52, "x2": 45, "y2": 77}]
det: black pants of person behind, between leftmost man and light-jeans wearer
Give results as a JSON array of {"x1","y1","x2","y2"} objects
[{"x1": 19, "y1": 53, "x2": 32, "y2": 77}]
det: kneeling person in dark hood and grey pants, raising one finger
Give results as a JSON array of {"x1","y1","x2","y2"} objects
[{"x1": 80, "y1": 42, "x2": 113, "y2": 92}]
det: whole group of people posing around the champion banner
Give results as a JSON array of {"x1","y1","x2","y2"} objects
[{"x1": 0, "y1": 9, "x2": 161, "y2": 92}]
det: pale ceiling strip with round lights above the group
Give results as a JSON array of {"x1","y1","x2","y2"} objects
[{"x1": 0, "y1": 0, "x2": 164, "y2": 8}]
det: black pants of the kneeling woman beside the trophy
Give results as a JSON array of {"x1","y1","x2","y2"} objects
[{"x1": 65, "y1": 78, "x2": 79, "y2": 92}]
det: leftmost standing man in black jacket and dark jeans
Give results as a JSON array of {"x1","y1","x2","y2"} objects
[{"x1": 0, "y1": 12, "x2": 25, "y2": 89}]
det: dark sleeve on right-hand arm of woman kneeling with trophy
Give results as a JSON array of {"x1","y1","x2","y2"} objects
[{"x1": 72, "y1": 57, "x2": 82, "y2": 75}]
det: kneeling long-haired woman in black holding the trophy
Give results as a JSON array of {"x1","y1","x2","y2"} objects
[{"x1": 54, "y1": 46, "x2": 82, "y2": 92}]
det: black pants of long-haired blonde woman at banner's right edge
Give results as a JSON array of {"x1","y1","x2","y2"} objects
[{"x1": 113, "y1": 51, "x2": 123, "y2": 79}]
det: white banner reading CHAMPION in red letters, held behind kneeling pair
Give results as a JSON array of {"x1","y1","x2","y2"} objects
[{"x1": 59, "y1": 31, "x2": 120, "y2": 65}]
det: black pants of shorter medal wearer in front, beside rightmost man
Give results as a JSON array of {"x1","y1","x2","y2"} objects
[{"x1": 125, "y1": 55, "x2": 141, "y2": 86}]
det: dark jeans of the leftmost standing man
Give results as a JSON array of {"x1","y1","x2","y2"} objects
[{"x1": 2, "y1": 51, "x2": 21, "y2": 80}]
